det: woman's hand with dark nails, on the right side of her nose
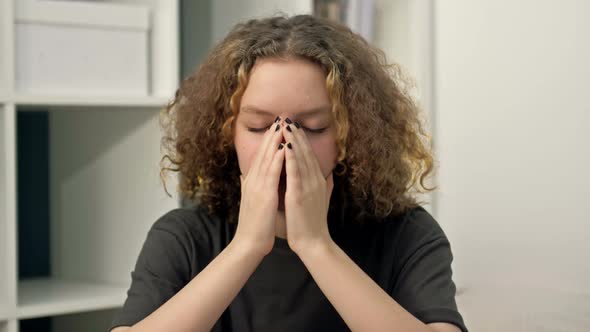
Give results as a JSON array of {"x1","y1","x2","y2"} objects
[{"x1": 283, "y1": 124, "x2": 334, "y2": 255}]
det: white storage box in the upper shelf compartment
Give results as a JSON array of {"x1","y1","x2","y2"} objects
[{"x1": 14, "y1": 0, "x2": 150, "y2": 96}]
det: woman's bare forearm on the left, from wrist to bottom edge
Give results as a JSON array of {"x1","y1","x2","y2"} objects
[{"x1": 128, "y1": 242, "x2": 264, "y2": 332}]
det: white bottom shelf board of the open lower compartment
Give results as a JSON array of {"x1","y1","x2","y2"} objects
[{"x1": 16, "y1": 279, "x2": 127, "y2": 319}]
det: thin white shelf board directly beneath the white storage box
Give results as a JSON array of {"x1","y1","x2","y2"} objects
[{"x1": 13, "y1": 95, "x2": 168, "y2": 108}]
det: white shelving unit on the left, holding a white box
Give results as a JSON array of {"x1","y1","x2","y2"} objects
[{"x1": 0, "y1": 0, "x2": 180, "y2": 332}]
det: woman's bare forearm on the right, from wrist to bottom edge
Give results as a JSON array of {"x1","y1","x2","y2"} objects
[{"x1": 298, "y1": 240, "x2": 431, "y2": 332}]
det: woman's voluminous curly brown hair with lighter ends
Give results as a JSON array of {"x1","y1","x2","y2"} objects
[{"x1": 160, "y1": 15, "x2": 435, "y2": 222}]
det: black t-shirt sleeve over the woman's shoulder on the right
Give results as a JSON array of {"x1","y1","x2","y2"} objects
[{"x1": 388, "y1": 207, "x2": 466, "y2": 331}]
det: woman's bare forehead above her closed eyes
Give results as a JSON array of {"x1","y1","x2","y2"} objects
[{"x1": 240, "y1": 58, "x2": 330, "y2": 114}]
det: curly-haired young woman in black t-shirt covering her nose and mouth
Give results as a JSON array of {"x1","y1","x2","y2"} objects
[{"x1": 113, "y1": 15, "x2": 466, "y2": 332}]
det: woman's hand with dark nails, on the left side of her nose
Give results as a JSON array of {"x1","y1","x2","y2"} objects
[{"x1": 234, "y1": 123, "x2": 285, "y2": 255}]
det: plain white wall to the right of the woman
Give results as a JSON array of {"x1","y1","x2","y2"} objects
[{"x1": 434, "y1": 0, "x2": 590, "y2": 331}]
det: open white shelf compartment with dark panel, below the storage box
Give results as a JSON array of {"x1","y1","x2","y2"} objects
[{"x1": 15, "y1": 106, "x2": 178, "y2": 319}]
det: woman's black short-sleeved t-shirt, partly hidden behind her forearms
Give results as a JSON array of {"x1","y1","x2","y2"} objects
[{"x1": 112, "y1": 207, "x2": 467, "y2": 332}]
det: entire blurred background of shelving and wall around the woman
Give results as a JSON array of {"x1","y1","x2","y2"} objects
[{"x1": 0, "y1": 0, "x2": 590, "y2": 332}]
